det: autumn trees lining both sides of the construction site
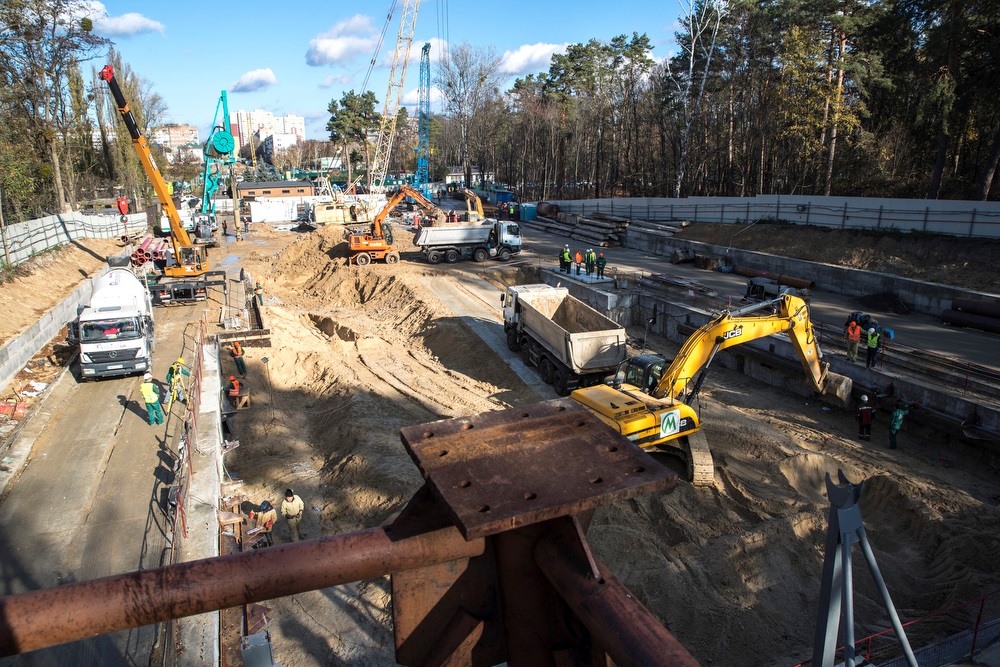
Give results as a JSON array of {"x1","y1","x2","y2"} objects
[{"x1": 0, "y1": 0, "x2": 1000, "y2": 223}]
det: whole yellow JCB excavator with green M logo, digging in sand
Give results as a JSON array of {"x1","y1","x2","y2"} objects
[{"x1": 570, "y1": 294, "x2": 851, "y2": 486}]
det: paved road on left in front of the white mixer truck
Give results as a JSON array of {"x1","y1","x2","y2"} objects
[{"x1": 0, "y1": 305, "x2": 202, "y2": 667}]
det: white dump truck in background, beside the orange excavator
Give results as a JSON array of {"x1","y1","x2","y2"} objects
[{"x1": 414, "y1": 220, "x2": 521, "y2": 264}]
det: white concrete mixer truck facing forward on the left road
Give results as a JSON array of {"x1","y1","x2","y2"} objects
[{"x1": 69, "y1": 268, "x2": 156, "y2": 379}]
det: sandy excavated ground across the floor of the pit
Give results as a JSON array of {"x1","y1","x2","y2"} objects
[{"x1": 0, "y1": 220, "x2": 1000, "y2": 666}]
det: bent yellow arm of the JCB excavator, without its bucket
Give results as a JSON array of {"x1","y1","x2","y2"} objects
[{"x1": 650, "y1": 294, "x2": 841, "y2": 399}]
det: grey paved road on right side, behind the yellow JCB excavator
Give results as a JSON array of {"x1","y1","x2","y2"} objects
[{"x1": 520, "y1": 227, "x2": 1000, "y2": 370}]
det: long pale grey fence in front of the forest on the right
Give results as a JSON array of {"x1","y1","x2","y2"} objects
[{"x1": 548, "y1": 195, "x2": 1000, "y2": 238}]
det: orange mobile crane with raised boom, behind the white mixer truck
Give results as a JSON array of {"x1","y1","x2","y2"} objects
[{"x1": 100, "y1": 65, "x2": 226, "y2": 303}]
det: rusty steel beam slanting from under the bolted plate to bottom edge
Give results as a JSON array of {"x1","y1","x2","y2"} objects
[{"x1": 535, "y1": 534, "x2": 698, "y2": 667}]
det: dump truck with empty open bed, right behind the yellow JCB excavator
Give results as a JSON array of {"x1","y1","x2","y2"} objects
[{"x1": 500, "y1": 285, "x2": 628, "y2": 396}]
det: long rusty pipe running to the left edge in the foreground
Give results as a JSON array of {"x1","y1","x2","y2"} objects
[{"x1": 0, "y1": 526, "x2": 484, "y2": 656}]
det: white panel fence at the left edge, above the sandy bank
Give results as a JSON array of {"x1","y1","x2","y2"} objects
[{"x1": 0, "y1": 212, "x2": 149, "y2": 266}]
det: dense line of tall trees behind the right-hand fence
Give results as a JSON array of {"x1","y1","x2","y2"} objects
[{"x1": 360, "y1": 0, "x2": 1000, "y2": 200}]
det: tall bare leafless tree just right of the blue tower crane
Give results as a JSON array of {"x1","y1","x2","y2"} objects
[{"x1": 436, "y1": 42, "x2": 503, "y2": 186}]
